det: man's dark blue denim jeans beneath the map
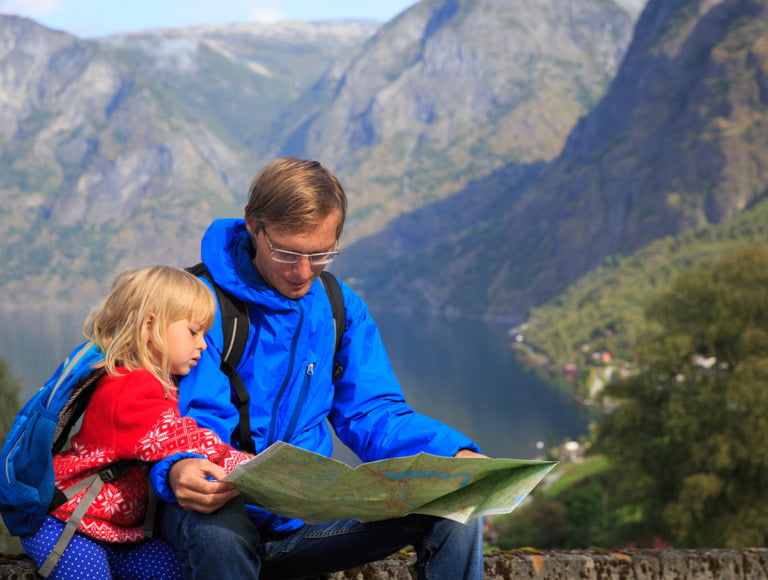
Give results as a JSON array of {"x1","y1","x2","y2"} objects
[{"x1": 159, "y1": 499, "x2": 483, "y2": 580}]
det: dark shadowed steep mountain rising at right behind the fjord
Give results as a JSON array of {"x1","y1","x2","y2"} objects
[{"x1": 339, "y1": 0, "x2": 768, "y2": 322}]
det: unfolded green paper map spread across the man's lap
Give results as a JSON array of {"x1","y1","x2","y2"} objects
[{"x1": 222, "y1": 442, "x2": 557, "y2": 523}]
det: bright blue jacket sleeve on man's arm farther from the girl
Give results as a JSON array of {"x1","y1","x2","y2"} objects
[{"x1": 330, "y1": 286, "x2": 480, "y2": 461}]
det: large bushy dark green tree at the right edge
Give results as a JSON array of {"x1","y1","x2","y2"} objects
[{"x1": 595, "y1": 246, "x2": 768, "y2": 547}]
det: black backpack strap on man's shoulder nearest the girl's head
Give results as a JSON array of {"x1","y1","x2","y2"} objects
[{"x1": 187, "y1": 262, "x2": 256, "y2": 454}]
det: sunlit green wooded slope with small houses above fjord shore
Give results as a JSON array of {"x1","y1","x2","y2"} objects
[{"x1": 515, "y1": 200, "x2": 768, "y2": 398}]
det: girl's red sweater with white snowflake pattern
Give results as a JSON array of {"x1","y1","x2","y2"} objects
[{"x1": 51, "y1": 369, "x2": 249, "y2": 542}]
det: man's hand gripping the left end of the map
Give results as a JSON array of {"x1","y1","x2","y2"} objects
[{"x1": 168, "y1": 457, "x2": 240, "y2": 514}]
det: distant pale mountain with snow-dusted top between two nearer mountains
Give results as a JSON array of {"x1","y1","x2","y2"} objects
[{"x1": 96, "y1": 20, "x2": 381, "y2": 157}]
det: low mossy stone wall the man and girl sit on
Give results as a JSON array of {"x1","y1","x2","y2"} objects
[{"x1": 0, "y1": 548, "x2": 768, "y2": 580}]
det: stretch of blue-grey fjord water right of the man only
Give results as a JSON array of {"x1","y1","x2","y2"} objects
[{"x1": 374, "y1": 313, "x2": 589, "y2": 459}]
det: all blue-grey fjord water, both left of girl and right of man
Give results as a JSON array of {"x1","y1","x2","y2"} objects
[{"x1": 0, "y1": 310, "x2": 588, "y2": 461}]
